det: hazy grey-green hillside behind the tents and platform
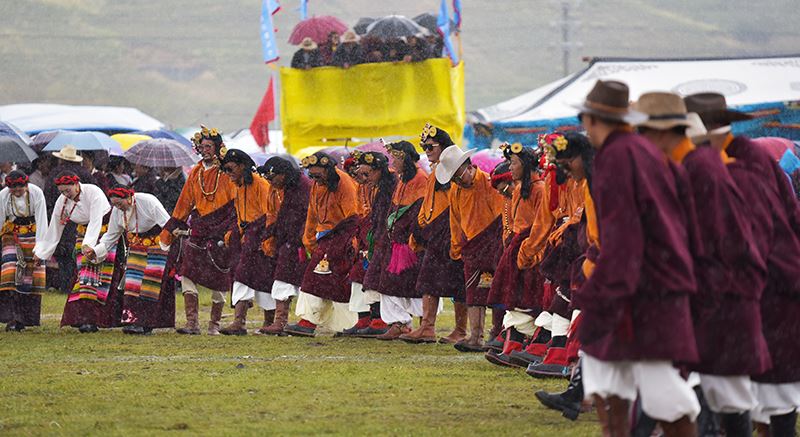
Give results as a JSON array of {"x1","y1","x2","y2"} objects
[{"x1": 0, "y1": 0, "x2": 800, "y2": 130}]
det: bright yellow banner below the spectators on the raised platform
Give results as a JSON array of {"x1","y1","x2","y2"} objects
[{"x1": 281, "y1": 58, "x2": 465, "y2": 153}]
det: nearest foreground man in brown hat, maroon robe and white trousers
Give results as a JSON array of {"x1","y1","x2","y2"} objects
[{"x1": 573, "y1": 80, "x2": 700, "y2": 436}]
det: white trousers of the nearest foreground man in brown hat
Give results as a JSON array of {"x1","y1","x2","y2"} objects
[{"x1": 581, "y1": 353, "x2": 700, "y2": 422}]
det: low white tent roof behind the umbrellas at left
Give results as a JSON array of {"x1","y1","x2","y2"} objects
[{"x1": 0, "y1": 103, "x2": 164, "y2": 134}]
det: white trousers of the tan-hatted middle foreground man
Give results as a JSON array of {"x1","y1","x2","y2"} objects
[{"x1": 700, "y1": 373, "x2": 757, "y2": 414}]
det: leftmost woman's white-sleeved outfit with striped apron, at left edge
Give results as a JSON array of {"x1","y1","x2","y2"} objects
[{"x1": 0, "y1": 183, "x2": 47, "y2": 326}]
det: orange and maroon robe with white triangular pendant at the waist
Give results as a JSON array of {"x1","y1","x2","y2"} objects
[{"x1": 300, "y1": 169, "x2": 358, "y2": 303}]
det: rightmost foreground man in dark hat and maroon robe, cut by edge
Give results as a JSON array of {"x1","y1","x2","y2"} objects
[{"x1": 686, "y1": 93, "x2": 800, "y2": 435}]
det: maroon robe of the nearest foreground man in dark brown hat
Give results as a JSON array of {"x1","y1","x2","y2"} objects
[{"x1": 573, "y1": 131, "x2": 698, "y2": 362}]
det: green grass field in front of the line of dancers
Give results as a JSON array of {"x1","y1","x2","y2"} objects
[{"x1": 0, "y1": 294, "x2": 599, "y2": 436}]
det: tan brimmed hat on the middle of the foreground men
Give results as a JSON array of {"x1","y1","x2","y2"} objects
[{"x1": 632, "y1": 92, "x2": 705, "y2": 133}]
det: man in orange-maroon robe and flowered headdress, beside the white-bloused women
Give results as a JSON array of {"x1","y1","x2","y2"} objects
[{"x1": 160, "y1": 126, "x2": 236, "y2": 335}]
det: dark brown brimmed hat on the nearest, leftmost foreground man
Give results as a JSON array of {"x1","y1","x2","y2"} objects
[{"x1": 572, "y1": 80, "x2": 647, "y2": 124}]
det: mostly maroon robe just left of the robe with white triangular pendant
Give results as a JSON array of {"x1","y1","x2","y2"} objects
[{"x1": 265, "y1": 174, "x2": 311, "y2": 287}]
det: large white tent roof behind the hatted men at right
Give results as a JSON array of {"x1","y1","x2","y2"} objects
[{"x1": 470, "y1": 55, "x2": 800, "y2": 124}]
